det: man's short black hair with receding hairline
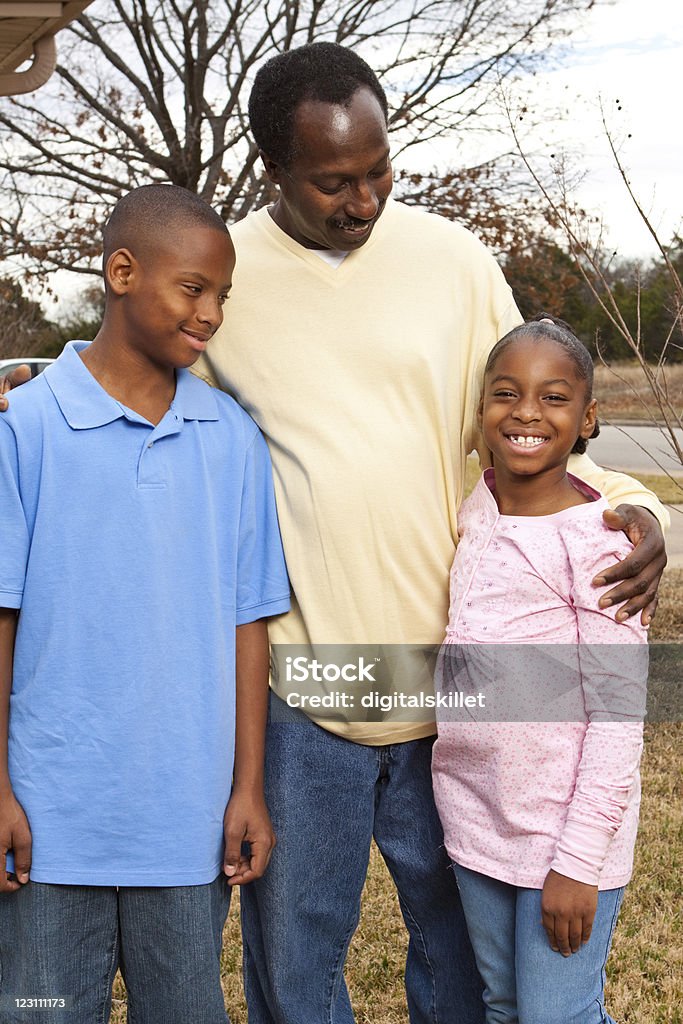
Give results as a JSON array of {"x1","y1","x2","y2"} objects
[{"x1": 249, "y1": 43, "x2": 389, "y2": 167}]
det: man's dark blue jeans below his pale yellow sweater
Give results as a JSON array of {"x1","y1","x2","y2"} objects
[{"x1": 241, "y1": 695, "x2": 483, "y2": 1024}]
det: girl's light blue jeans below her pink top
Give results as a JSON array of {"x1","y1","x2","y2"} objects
[{"x1": 454, "y1": 864, "x2": 624, "y2": 1024}]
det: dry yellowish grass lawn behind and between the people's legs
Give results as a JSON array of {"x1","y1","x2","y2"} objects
[{"x1": 112, "y1": 569, "x2": 683, "y2": 1024}]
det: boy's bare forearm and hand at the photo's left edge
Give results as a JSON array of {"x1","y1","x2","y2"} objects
[{"x1": 0, "y1": 608, "x2": 31, "y2": 892}]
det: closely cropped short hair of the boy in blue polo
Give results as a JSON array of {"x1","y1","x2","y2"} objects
[{"x1": 102, "y1": 184, "x2": 228, "y2": 265}]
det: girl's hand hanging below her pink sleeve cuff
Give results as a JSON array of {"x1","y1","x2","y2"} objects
[{"x1": 541, "y1": 870, "x2": 598, "y2": 956}]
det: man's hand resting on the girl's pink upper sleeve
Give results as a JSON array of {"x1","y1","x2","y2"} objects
[{"x1": 593, "y1": 505, "x2": 667, "y2": 626}]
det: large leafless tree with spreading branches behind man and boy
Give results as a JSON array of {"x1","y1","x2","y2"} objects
[{"x1": 0, "y1": 0, "x2": 596, "y2": 272}]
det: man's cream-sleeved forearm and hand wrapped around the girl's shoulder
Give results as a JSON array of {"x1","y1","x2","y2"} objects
[{"x1": 568, "y1": 455, "x2": 670, "y2": 626}]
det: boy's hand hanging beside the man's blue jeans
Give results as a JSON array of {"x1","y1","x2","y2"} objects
[{"x1": 223, "y1": 790, "x2": 275, "y2": 886}]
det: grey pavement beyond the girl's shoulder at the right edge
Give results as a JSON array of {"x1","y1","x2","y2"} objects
[{"x1": 588, "y1": 426, "x2": 683, "y2": 568}]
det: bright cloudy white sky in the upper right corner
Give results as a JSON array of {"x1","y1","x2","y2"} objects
[{"x1": 389, "y1": 0, "x2": 683, "y2": 260}]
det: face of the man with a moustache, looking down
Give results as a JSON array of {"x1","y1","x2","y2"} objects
[{"x1": 263, "y1": 87, "x2": 393, "y2": 252}]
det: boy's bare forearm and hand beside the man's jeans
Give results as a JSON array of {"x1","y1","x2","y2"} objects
[{"x1": 223, "y1": 618, "x2": 275, "y2": 886}]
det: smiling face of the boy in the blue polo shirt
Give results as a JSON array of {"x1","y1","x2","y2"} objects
[{"x1": 117, "y1": 225, "x2": 234, "y2": 369}]
